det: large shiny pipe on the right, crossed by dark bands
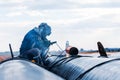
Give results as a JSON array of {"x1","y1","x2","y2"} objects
[{"x1": 46, "y1": 56, "x2": 120, "y2": 80}]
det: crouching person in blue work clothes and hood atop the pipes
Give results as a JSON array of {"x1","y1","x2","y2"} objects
[{"x1": 19, "y1": 23, "x2": 56, "y2": 63}]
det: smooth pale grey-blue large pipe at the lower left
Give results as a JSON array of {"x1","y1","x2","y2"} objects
[{"x1": 0, "y1": 59, "x2": 63, "y2": 80}]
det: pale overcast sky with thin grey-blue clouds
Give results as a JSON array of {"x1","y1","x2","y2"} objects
[{"x1": 0, "y1": 0, "x2": 120, "y2": 51}]
